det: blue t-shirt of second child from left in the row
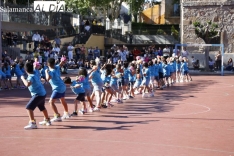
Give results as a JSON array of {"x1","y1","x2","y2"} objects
[{"x1": 49, "y1": 66, "x2": 66, "y2": 93}]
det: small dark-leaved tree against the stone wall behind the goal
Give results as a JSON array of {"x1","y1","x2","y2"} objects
[{"x1": 193, "y1": 21, "x2": 219, "y2": 70}]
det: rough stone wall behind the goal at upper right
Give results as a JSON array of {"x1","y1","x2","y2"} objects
[{"x1": 181, "y1": 0, "x2": 234, "y2": 53}]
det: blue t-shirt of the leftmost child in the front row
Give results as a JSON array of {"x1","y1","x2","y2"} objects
[{"x1": 27, "y1": 74, "x2": 46, "y2": 96}]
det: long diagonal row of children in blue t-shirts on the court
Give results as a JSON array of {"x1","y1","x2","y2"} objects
[{"x1": 0, "y1": 56, "x2": 192, "y2": 129}]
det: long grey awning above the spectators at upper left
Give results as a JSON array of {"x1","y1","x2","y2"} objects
[{"x1": 2, "y1": 21, "x2": 56, "y2": 32}]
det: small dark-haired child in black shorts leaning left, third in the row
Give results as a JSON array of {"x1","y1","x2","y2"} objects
[{"x1": 63, "y1": 75, "x2": 86, "y2": 116}]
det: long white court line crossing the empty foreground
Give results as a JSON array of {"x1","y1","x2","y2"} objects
[{"x1": 0, "y1": 137, "x2": 234, "y2": 154}]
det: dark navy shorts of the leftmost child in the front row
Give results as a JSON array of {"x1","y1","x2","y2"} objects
[{"x1": 26, "y1": 95, "x2": 46, "y2": 111}]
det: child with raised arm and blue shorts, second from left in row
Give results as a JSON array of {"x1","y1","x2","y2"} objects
[{"x1": 45, "y1": 58, "x2": 70, "y2": 122}]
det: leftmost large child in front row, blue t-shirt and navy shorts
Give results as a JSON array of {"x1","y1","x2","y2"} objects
[{"x1": 21, "y1": 62, "x2": 51, "y2": 129}]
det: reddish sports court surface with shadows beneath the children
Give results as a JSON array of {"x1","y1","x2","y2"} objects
[{"x1": 0, "y1": 76, "x2": 234, "y2": 156}]
